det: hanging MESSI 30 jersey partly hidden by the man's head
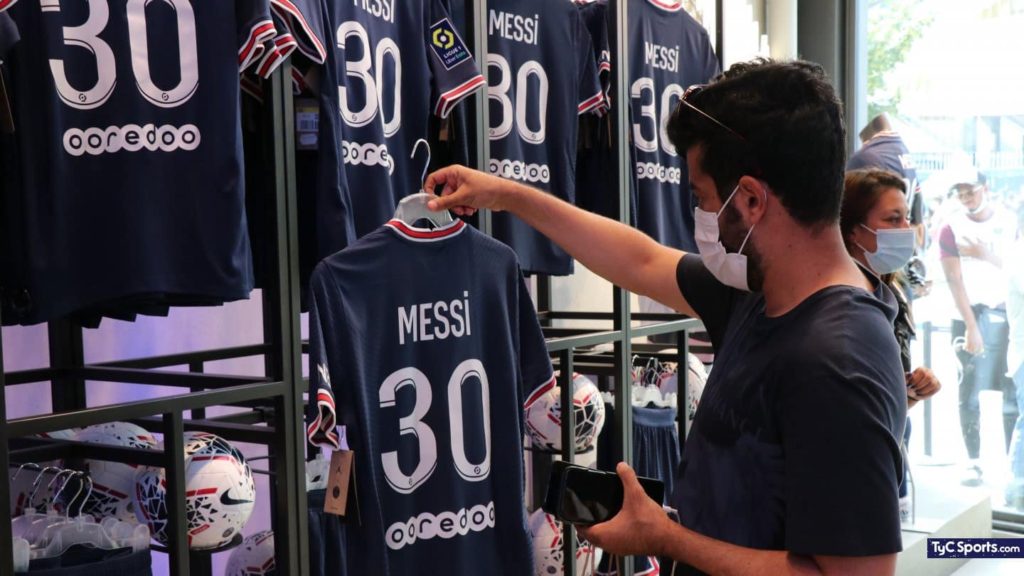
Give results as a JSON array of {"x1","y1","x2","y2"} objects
[{"x1": 629, "y1": 0, "x2": 719, "y2": 252}]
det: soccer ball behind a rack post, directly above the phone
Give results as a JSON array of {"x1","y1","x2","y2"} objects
[{"x1": 526, "y1": 374, "x2": 604, "y2": 452}]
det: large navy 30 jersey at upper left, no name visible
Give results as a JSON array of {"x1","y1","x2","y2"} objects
[{"x1": 0, "y1": 0, "x2": 274, "y2": 324}]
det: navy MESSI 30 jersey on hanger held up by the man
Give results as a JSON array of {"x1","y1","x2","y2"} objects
[{"x1": 307, "y1": 220, "x2": 554, "y2": 576}]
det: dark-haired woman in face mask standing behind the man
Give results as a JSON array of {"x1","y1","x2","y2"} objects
[{"x1": 840, "y1": 168, "x2": 942, "y2": 522}]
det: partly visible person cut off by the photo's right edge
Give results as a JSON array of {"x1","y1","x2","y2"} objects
[{"x1": 1006, "y1": 202, "x2": 1024, "y2": 509}]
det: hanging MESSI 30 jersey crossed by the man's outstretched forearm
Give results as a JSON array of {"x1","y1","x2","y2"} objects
[{"x1": 487, "y1": 0, "x2": 604, "y2": 276}]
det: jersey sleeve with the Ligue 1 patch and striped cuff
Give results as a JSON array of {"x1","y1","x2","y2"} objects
[{"x1": 424, "y1": 0, "x2": 486, "y2": 118}]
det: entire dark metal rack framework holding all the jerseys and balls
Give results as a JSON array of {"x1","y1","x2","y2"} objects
[{"x1": 0, "y1": 0, "x2": 723, "y2": 576}]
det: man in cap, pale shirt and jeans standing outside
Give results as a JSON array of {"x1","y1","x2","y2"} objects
[{"x1": 939, "y1": 170, "x2": 1017, "y2": 486}]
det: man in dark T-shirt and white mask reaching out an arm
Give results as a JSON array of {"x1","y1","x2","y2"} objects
[{"x1": 426, "y1": 61, "x2": 906, "y2": 574}]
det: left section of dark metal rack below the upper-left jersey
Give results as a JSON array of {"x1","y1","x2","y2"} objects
[{"x1": 0, "y1": 63, "x2": 308, "y2": 576}]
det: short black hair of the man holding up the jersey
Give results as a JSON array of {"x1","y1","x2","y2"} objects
[{"x1": 668, "y1": 58, "x2": 846, "y2": 225}]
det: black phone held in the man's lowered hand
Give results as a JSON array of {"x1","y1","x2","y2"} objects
[{"x1": 542, "y1": 462, "x2": 665, "y2": 526}]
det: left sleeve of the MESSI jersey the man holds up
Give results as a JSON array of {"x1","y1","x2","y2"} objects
[{"x1": 306, "y1": 271, "x2": 344, "y2": 450}]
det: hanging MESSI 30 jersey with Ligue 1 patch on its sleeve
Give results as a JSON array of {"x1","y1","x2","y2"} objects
[{"x1": 274, "y1": 0, "x2": 485, "y2": 256}]
